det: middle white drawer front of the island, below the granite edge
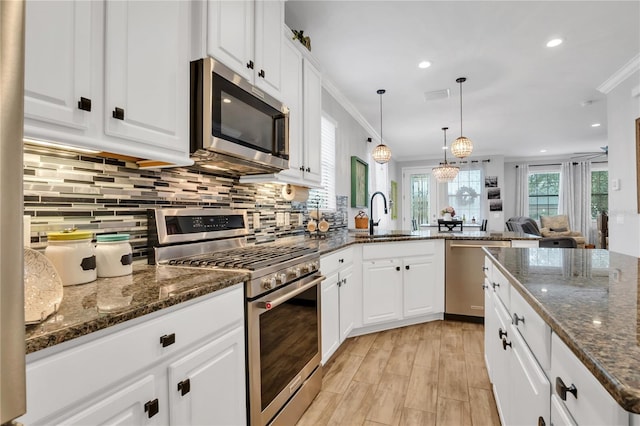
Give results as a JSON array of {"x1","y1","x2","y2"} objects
[{"x1": 510, "y1": 288, "x2": 551, "y2": 371}]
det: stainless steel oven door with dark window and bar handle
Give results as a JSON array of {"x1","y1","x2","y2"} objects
[{"x1": 247, "y1": 274, "x2": 324, "y2": 426}]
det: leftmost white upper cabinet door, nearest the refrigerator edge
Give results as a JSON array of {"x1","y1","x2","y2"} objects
[{"x1": 24, "y1": 1, "x2": 93, "y2": 136}]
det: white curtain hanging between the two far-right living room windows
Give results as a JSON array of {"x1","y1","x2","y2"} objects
[{"x1": 559, "y1": 161, "x2": 592, "y2": 244}]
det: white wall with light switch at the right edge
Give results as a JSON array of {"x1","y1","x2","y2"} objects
[{"x1": 607, "y1": 66, "x2": 640, "y2": 256}]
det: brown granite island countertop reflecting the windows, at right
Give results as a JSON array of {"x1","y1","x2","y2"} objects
[{"x1": 485, "y1": 248, "x2": 640, "y2": 413}]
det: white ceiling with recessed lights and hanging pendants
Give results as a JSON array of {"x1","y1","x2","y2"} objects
[{"x1": 285, "y1": 0, "x2": 640, "y2": 161}]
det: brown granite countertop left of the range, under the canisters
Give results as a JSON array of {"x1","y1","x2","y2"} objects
[{"x1": 25, "y1": 264, "x2": 249, "y2": 354}]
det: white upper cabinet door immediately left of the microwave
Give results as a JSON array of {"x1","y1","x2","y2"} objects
[{"x1": 105, "y1": 1, "x2": 190, "y2": 153}]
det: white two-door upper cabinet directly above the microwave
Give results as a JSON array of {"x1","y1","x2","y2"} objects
[{"x1": 207, "y1": 0, "x2": 284, "y2": 98}]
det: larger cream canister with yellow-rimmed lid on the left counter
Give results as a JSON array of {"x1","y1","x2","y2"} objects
[{"x1": 44, "y1": 229, "x2": 97, "y2": 286}]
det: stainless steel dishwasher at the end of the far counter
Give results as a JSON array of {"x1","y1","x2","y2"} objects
[{"x1": 444, "y1": 240, "x2": 511, "y2": 322}]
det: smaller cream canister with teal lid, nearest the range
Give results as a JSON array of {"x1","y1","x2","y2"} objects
[{"x1": 96, "y1": 234, "x2": 133, "y2": 278}]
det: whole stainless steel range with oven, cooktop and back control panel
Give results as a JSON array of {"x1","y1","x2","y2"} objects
[{"x1": 148, "y1": 208, "x2": 324, "y2": 426}]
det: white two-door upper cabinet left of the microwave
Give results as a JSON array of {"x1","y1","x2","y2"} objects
[{"x1": 24, "y1": 0, "x2": 192, "y2": 166}]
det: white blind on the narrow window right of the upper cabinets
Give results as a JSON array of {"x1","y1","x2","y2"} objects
[{"x1": 308, "y1": 116, "x2": 336, "y2": 210}]
